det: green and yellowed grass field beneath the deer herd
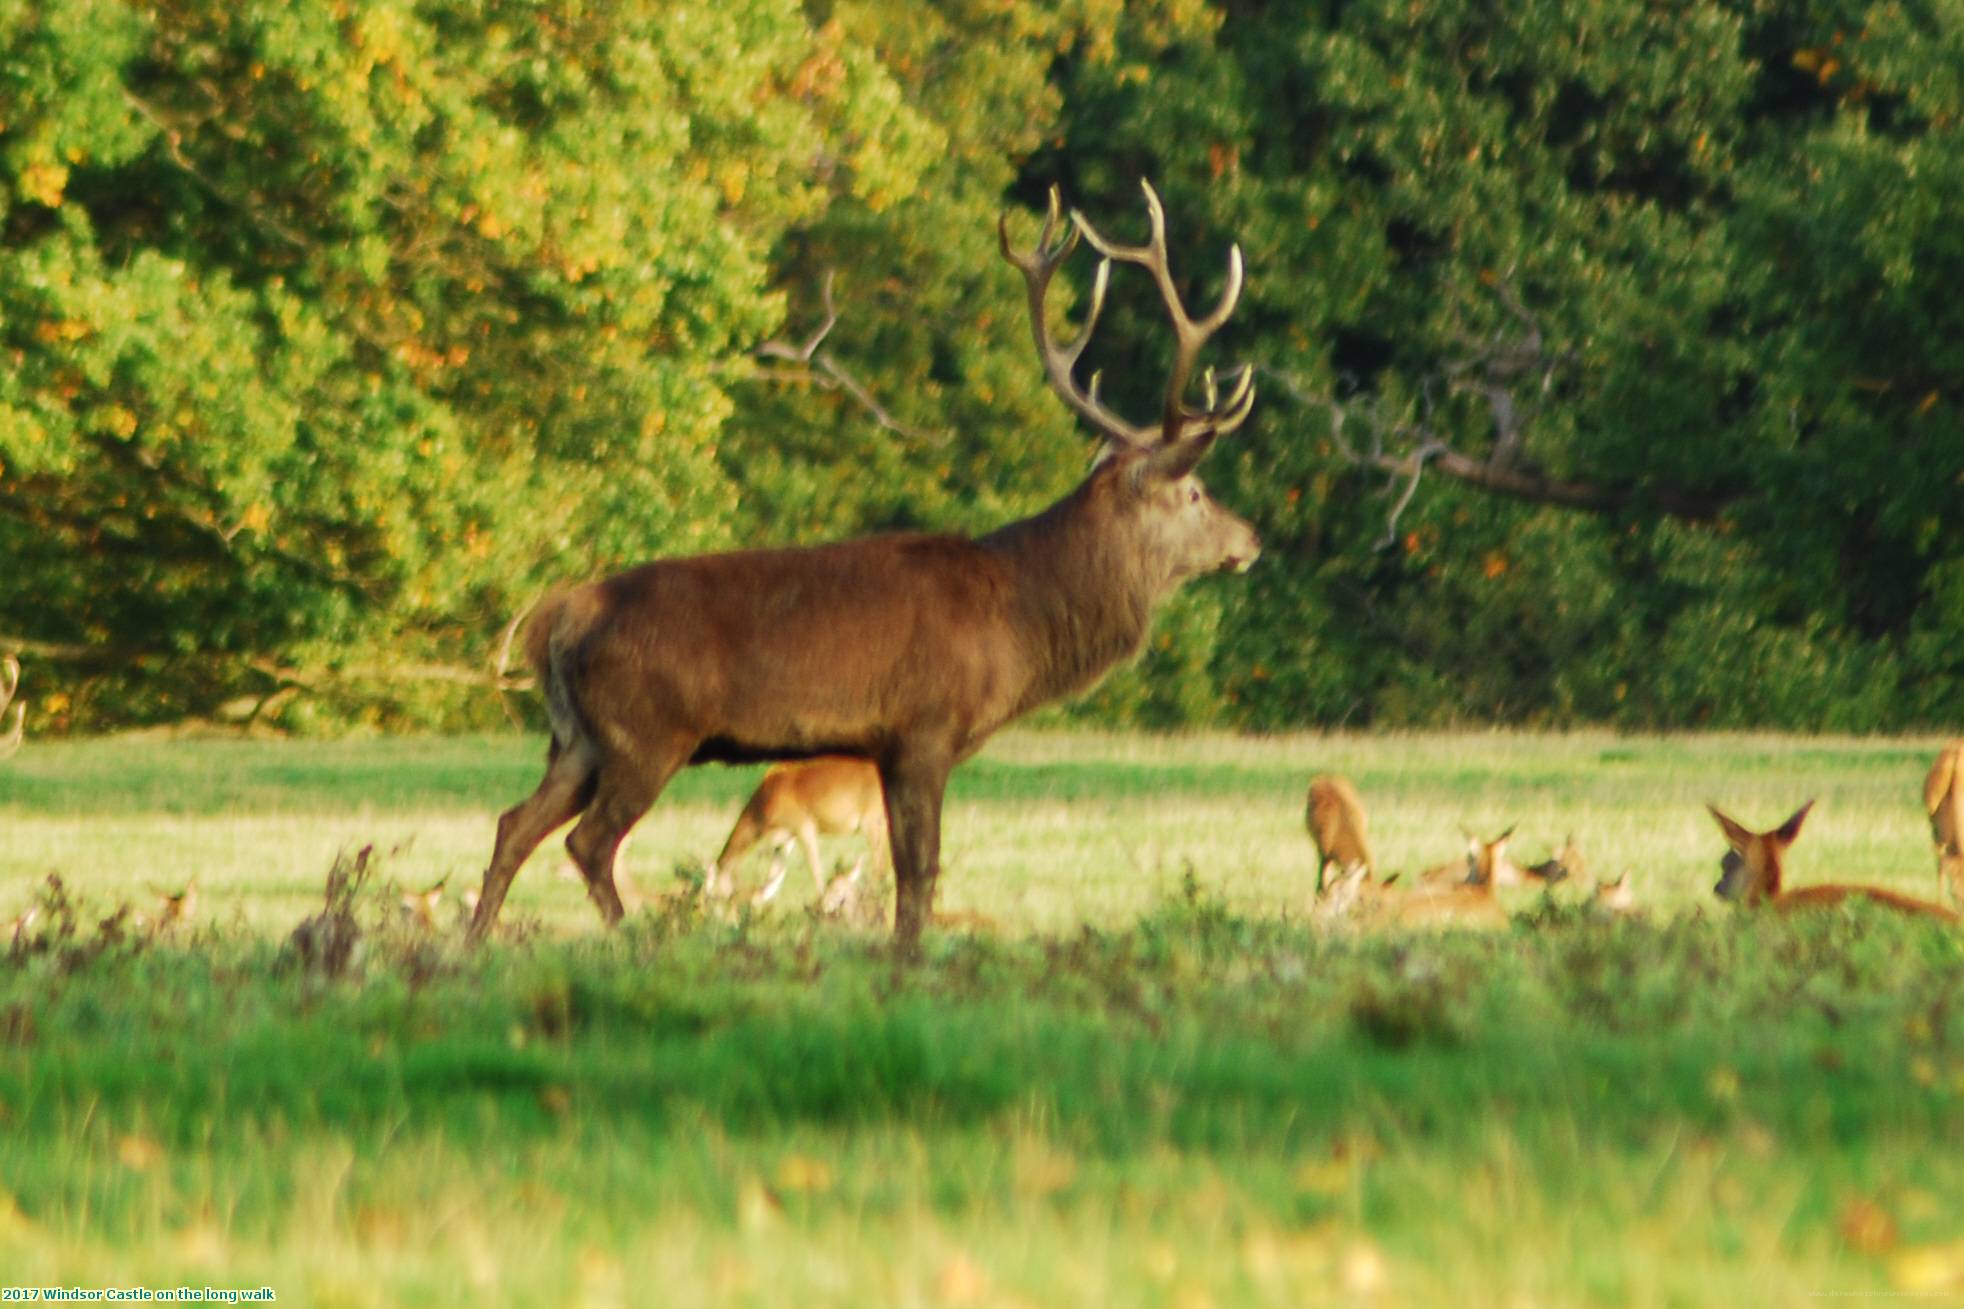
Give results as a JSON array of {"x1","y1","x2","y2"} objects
[{"x1": 0, "y1": 733, "x2": 1964, "y2": 1307}]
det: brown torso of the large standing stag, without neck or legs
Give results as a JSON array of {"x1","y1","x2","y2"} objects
[{"x1": 526, "y1": 535, "x2": 1029, "y2": 763}]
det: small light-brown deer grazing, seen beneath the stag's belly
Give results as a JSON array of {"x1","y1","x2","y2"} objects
[{"x1": 703, "y1": 755, "x2": 888, "y2": 904}]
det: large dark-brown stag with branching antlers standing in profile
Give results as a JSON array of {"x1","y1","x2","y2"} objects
[{"x1": 469, "y1": 178, "x2": 1261, "y2": 953}]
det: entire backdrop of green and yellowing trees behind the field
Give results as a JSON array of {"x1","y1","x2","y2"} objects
[{"x1": 0, "y1": 0, "x2": 1964, "y2": 729}]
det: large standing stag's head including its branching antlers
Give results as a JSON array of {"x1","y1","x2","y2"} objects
[{"x1": 998, "y1": 183, "x2": 1261, "y2": 592}]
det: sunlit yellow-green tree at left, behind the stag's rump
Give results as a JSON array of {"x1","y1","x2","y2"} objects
[{"x1": 0, "y1": 0, "x2": 939, "y2": 723}]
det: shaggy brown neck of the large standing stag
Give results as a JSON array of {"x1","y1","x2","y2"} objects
[{"x1": 976, "y1": 482, "x2": 1163, "y2": 711}]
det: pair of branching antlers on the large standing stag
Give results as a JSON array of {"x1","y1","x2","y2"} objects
[{"x1": 996, "y1": 181, "x2": 1255, "y2": 448}]
